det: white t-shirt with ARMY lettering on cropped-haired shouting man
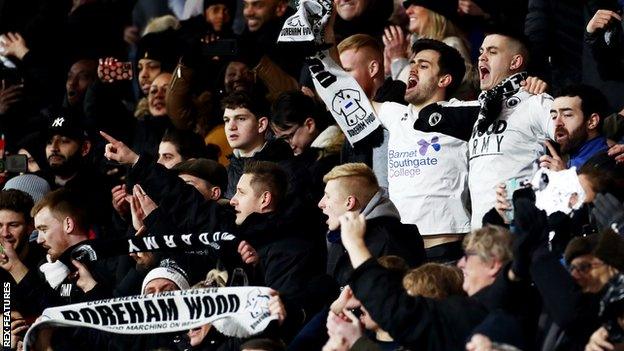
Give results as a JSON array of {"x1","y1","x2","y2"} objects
[{"x1": 468, "y1": 90, "x2": 554, "y2": 229}]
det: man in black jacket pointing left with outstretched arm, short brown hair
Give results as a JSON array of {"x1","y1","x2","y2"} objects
[{"x1": 102, "y1": 129, "x2": 334, "y2": 333}]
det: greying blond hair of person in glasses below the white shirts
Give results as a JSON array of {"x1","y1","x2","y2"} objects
[{"x1": 463, "y1": 225, "x2": 513, "y2": 264}]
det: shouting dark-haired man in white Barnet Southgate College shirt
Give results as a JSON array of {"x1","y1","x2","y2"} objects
[{"x1": 326, "y1": 28, "x2": 471, "y2": 261}]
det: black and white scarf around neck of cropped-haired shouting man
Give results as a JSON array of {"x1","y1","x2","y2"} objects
[{"x1": 477, "y1": 72, "x2": 528, "y2": 133}]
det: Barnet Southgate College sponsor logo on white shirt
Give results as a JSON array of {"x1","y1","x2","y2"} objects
[{"x1": 388, "y1": 136, "x2": 442, "y2": 178}]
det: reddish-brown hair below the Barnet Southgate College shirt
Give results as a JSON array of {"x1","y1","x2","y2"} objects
[{"x1": 403, "y1": 263, "x2": 464, "y2": 299}]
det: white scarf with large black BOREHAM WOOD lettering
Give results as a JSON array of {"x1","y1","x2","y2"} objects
[{"x1": 24, "y1": 286, "x2": 277, "y2": 350}]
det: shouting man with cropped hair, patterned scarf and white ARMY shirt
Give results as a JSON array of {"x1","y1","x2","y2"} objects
[{"x1": 466, "y1": 31, "x2": 554, "y2": 229}]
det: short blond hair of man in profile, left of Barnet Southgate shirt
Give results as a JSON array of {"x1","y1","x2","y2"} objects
[{"x1": 323, "y1": 163, "x2": 379, "y2": 206}]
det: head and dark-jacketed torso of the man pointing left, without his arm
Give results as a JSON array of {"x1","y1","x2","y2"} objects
[{"x1": 230, "y1": 161, "x2": 326, "y2": 332}]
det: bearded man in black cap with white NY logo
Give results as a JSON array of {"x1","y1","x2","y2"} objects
[{"x1": 45, "y1": 110, "x2": 112, "y2": 236}]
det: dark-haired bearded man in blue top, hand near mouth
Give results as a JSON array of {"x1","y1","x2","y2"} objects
[{"x1": 540, "y1": 84, "x2": 609, "y2": 171}]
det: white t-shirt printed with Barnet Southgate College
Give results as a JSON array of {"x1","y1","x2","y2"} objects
[{"x1": 378, "y1": 102, "x2": 470, "y2": 235}]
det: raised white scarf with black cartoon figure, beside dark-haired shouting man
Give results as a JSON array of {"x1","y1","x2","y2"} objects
[{"x1": 307, "y1": 51, "x2": 380, "y2": 145}]
